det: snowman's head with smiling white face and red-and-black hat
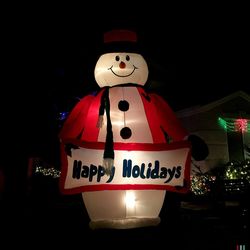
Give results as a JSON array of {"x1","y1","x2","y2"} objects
[{"x1": 94, "y1": 30, "x2": 148, "y2": 88}]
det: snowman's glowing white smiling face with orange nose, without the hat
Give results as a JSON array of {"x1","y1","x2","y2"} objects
[{"x1": 94, "y1": 53, "x2": 148, "y2": 88}]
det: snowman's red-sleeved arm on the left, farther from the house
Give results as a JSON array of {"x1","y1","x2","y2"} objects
[{"x1": 59, "y1": 95, "x2": 94, "y2": 140}]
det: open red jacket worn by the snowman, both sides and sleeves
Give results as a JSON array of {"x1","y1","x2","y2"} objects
[{"x1": 59, "y1": 86, "x2": 187, "y2": 143}]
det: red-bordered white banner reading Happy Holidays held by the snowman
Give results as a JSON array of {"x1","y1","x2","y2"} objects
[{"x1": 60, "y1": 141, "x2": 191, "y2": 193}]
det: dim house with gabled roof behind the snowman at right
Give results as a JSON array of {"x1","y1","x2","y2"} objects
[{"x1": 176, "y1": 91, "x2": 250, "y2": 175}]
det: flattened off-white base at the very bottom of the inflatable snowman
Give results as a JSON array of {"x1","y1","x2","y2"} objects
[{"x1": 89, "y1": 217, "x2": 161, "y2": 230}]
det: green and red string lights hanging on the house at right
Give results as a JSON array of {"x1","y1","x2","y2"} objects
[{"x1": 218, "y1": 117, "x2": 250, "y2": 133}]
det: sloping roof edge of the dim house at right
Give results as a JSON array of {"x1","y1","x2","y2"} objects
[{"x1": 176, "y1": 90, "x2": 250, "y2": 117}]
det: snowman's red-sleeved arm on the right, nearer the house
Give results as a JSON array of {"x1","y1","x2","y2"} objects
[{"x1": 150, "y1": 94, "x2": 188, "y2": 141}]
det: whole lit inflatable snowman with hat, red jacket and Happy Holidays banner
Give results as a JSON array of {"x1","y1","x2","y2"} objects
[{"x1": 60, "y1": 30, "x2": 190, "y2": 228}]
